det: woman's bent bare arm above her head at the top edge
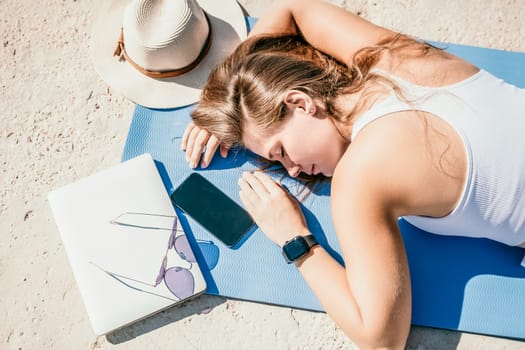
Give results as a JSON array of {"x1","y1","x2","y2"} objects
[{"x1": 250, "y1": 0, "x2": 394, "y2": 63}]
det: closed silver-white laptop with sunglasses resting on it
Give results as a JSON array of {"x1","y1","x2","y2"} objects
[{"x1": 48, "y1": 154, "x2": 206, "y2": 335}]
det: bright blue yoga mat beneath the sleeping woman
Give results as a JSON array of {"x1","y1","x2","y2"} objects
[{"x1": 122, "y1": 17, "x2": 525, "y2": 339}]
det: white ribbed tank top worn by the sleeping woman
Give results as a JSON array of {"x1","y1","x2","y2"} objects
[{"x1": 352, "y1": 70, "x2": 525, "y2": 245}]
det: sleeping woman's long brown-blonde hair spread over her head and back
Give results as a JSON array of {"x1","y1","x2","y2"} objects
[{"x1": 191, "y1": 35, "x2": 429, "y2": 146}]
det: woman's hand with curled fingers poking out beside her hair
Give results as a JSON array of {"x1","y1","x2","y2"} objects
[{"x1": 180, "y1": 122, "x2": 229, "y2": 168}]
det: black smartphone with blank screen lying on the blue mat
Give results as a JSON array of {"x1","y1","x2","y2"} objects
[{"x1": 171, "y1": 173, "x2": 254, "y2": 247}]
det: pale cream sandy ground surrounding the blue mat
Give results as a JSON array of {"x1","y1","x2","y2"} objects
[{"x1": 0, "y1": 0, "x2": 525, "y2": 349}]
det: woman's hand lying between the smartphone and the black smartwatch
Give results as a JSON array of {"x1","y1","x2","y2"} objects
[{"x1": 239, "y1": 171, "x2": 310, "y2": 247}]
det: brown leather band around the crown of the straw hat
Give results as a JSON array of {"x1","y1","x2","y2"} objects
[{"x1": 113, "y1": 11, "x2": 213, "y2": 79}]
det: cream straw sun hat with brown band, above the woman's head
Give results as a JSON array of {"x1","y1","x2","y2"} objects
[{"x1": 91, "y1": 0, "x2": 247, "y2": 108}]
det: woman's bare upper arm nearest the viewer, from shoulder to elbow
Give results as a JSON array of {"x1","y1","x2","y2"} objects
[{"x1": 326, "y1": 111, "x2": 466, "y2": 348}]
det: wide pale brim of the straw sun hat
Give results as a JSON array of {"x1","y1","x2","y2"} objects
[{"x1": 90, "y1": 0, "x2": 248, "y2": 109}]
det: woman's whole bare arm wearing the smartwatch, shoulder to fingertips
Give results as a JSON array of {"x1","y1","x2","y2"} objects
[{"x1": 240, "y1": 112, "x2": 464, "y2": 349}]
